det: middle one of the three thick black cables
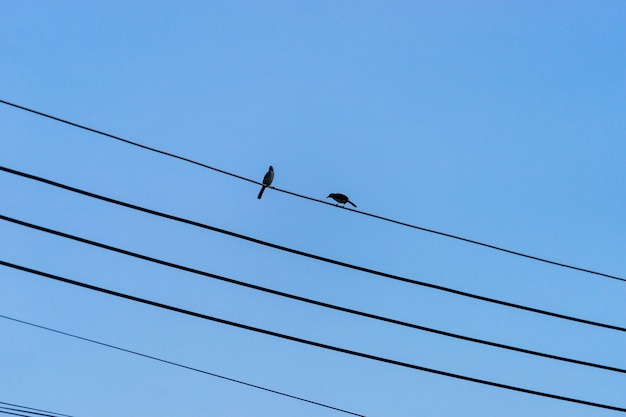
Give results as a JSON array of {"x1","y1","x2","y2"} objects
[{"x1": 0, "y1": 214, "x2": 626, "y2": 373}]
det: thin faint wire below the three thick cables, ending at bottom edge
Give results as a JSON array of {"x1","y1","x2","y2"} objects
[{"x1": 0, "y1": 314, "x2": 365, "y2": 417}]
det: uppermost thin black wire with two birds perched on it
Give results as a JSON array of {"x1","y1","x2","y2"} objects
[{"x1": 0, "y1": 100, "x2": 626, "y2": 282}]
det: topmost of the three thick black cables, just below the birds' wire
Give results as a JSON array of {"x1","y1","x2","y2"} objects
[{"x1": 0, "y1": 166, "x2": 626, "y2": 332}]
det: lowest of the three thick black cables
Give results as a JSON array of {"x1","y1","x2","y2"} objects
[{"x1": 0, "y1": 260, "x2": 626, "y2": 413}]
